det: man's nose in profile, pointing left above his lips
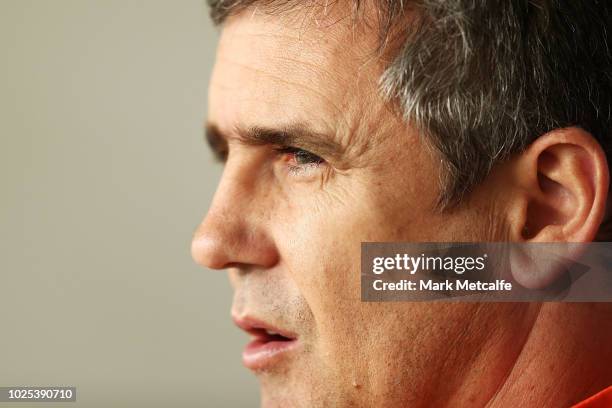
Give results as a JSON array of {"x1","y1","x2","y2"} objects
[{"x1": 191, "y1": 163, "x2": 278, "y2": 269}]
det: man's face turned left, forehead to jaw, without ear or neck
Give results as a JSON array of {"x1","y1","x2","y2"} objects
[{"x1": 192, "y1": 7, "x2": 527, "y2": 407}]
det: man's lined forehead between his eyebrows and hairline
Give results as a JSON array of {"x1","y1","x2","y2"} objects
[{"x1": 209, "y1": 10, "x2": 382, "y2": 135}]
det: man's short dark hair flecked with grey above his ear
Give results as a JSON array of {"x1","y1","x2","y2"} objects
[{"x1": 208, "y1": 0, "x2": 612, "y2": 214}]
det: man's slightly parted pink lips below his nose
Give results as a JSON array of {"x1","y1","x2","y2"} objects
[{"x1": 233, "y1": 317, "x2": 299, "y2": 370}]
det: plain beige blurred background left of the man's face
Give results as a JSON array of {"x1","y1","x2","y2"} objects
[{"x1": 0, "y1": 0, "x2": 258, "y2": 408}]
